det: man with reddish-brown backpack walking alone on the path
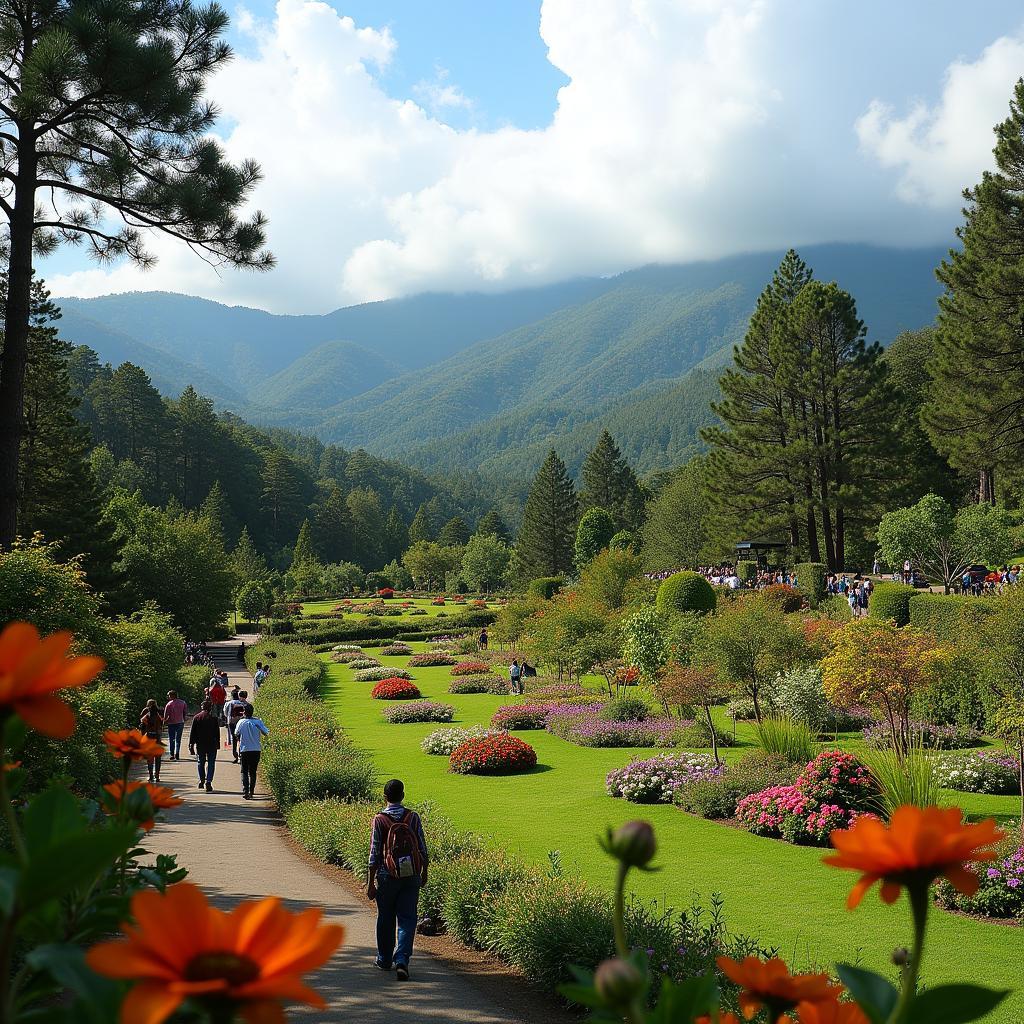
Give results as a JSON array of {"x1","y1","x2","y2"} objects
[{"x1": 367, "y1": 778, "x2": 429, "y2": 981}]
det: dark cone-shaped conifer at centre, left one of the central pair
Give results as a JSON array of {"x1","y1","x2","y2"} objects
[{"x1": 516, "y1": 450, "x2": 580, "y2": 578}]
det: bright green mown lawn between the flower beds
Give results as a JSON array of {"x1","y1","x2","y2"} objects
[{"x1": 325, "y1": 645, "x2": 1024, "y2": 1024}]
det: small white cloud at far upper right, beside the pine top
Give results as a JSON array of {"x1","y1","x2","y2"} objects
[{"x1": 856, "y1": 36, "x2": 1024, "y2": 207}]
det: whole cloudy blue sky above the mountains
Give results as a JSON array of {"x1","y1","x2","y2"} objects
[{"x1": 40, "y1": 0, "x2": 1024, "y2": 312}]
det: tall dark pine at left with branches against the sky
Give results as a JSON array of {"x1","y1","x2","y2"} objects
[{"x1": 0, "y1": 0, "x2": 272, "y2": 547}]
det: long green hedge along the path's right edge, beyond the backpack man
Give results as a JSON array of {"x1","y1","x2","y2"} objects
[{"x1": 246, "y1": 639, "x2": 376, "y2": 811}]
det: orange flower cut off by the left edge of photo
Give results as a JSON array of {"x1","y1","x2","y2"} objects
[{"x1": 0, "y1": 623, "x2": 105, "y2": 739}]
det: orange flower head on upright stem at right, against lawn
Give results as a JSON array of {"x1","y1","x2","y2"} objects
[{"x1": 825, "y1": 805, "x2": 1002, "y2": 909}]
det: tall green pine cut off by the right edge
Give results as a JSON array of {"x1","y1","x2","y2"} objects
[{"x1": 923, "y1": 79, "x2": 1024, "y2": 502}]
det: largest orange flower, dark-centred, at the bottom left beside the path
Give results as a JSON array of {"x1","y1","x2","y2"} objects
[{"x1": 86, "y1": 882, "x2": 344, "y2": 1024}]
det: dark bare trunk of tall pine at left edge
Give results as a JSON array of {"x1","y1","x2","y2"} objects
[{"x1": 0, "y1": 140, "x2": 36, "y2": 548}]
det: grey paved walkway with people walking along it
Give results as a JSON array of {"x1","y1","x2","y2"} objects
[{"x1": 144, "y1": 642, "x2": 552, "y2": 1024}]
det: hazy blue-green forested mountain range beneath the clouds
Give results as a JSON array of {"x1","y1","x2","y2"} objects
[{"x1": 58, "y1": 245, "x2": 945, "y2": 489}]
